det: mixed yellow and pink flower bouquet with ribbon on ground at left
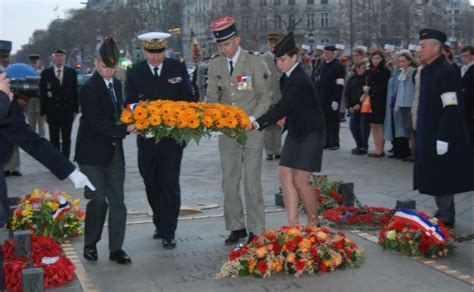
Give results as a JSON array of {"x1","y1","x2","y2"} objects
[{"x1": 10, "y1": 189, "x2": 85, "y2": 240}]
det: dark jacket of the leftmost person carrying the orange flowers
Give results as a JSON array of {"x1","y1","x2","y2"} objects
[{"x1": 75, "y1": 73, "x2": 127, "y2": 167}]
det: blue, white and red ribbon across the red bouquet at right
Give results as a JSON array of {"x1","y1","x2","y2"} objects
[{"x1": 392, "y1": 208, "x2": 446, "y2": 244}]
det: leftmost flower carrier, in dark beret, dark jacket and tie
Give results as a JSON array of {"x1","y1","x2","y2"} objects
[{"x1": 76, "y1": 36, "x2": 134, "y2": 264}]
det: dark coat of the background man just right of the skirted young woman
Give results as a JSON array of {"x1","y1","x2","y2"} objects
[{"x1": 315, "y1": 59, "x2": 346, "y2": 121}]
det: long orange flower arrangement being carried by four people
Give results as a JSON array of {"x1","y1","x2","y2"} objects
[{"x1": 120, "y1": 100, "x2": 250, "y2": 145}]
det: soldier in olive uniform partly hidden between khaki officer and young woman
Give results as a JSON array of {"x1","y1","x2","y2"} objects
[{"x1": 263, "y1": 32, "x2": 283, "y2": 160}]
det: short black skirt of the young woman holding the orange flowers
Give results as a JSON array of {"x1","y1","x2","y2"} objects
[{"x1": 280, "y1": 132, "x2": 326, "y2": 172}]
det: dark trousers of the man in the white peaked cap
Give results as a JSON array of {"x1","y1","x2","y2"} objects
[{"x1": 137, "y1": 136, "x2": 183, "y2": 239}]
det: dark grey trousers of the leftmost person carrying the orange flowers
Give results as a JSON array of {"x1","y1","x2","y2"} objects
[{"x1": 79, "y1": 145, "x2": 127, "y2": 252}]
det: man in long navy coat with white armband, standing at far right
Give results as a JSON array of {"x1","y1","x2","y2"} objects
[{"x1": 414, "y1": 29, "x2": 473, "y2": 227}]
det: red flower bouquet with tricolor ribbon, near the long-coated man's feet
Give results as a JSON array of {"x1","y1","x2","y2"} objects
[{"x1": 379, "y1": 208, "x2": 455, "y2": 257}]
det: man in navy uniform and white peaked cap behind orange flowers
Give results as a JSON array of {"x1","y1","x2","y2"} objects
[{"x1": 125, "y1": 32, "x2": 194, "y2": 249}]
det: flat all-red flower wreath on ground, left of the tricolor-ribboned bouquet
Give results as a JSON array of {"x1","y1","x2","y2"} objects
[{"x1": 322, "y1": 206, "x2": 392, "y2": 230}]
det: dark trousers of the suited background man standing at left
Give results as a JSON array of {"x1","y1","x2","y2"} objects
[{"x1": 48, "y1": 114, "x2": 73, "y2": 159}]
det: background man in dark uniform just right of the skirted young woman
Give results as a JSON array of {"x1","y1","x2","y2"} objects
[{"x1": 315, "y1": 46, "x2": 346, "y2": 150}]
